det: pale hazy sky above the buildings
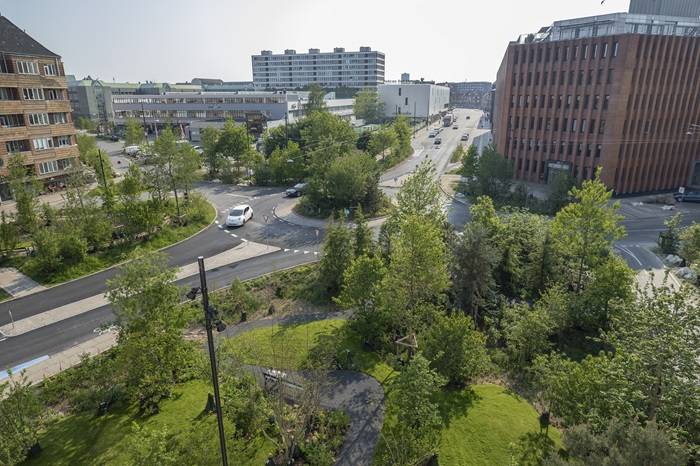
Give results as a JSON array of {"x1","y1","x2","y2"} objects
[{"x1": 0, "y1": 0, "x2": 628, "y2": 82}]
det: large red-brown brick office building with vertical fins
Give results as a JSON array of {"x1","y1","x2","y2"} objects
[{"x1": 493, "y1": 13, "x2": 700, "y2": 194}]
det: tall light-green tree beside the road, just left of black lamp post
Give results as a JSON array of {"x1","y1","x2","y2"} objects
[{"x1": 106, "y1": 253, "x2": 190, "y2": 413}]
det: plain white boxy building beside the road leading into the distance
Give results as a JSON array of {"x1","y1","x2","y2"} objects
[{"x1": 377, "y1": 82, "x2": 450, "y2": 118}]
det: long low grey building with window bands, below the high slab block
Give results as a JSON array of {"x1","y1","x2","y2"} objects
[{"x1": 112, "y1": 91, "x2": 353, "y2": 140}]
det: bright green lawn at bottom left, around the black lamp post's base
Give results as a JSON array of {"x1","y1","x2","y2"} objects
[{"x1": 25, "y1": 381, "x2": 274, "y2": 466}]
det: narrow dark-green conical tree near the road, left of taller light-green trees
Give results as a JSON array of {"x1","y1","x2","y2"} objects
[{"x1": 319, "y1": 219, "x2": 355, "y2": 296}]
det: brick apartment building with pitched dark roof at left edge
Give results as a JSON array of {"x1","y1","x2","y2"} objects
[{"x1": 0, "y1": 16, "x2": 79, "y2": 191}]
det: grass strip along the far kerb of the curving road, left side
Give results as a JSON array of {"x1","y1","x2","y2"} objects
[{"x1": 6, "y1": 202, "x2": 216, "y2": 285}]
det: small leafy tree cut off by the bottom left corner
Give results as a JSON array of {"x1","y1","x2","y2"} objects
[{"x1": 0, "y1": 375, "x2": 42, "y2": 465}]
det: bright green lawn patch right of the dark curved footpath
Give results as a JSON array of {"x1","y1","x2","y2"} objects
[{"x1": 439, "y1": 384, "x2": 561, "y2": 466}]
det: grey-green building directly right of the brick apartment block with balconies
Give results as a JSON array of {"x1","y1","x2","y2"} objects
[{"x1": 67, "y1": 76, "x2": 114, "y2": 125}]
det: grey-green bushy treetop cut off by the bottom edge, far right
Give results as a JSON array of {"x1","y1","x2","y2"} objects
[{"x1": 544, "y1": 419, "x2": 689, "y2": 466}]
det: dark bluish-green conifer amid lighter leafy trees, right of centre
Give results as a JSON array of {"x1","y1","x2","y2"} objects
[{"x1": 450, "y1": 223, "x2": 500, "y2": 322}]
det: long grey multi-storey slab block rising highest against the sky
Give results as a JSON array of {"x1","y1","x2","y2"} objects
[{"x1": 251, "y1": 47, "x2": 384, "y2": 90}]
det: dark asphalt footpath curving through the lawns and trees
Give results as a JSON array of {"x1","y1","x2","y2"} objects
[{"x1": 220, "y1": 311, "x2": 385, "y2": 466}]
